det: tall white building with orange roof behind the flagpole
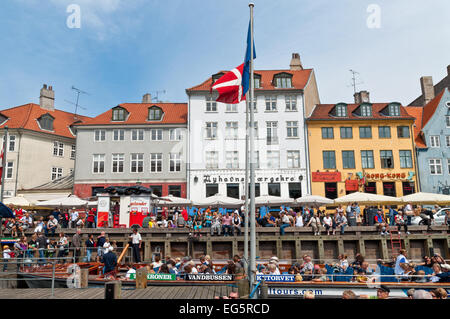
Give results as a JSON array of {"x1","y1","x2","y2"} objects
[{"x1": 186, "y1": 53, "x2": 319, "y2": 200}]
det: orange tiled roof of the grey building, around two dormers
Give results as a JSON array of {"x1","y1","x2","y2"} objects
[{"x1": 77, "y1": 103, "x2": 187, "y2": 126}]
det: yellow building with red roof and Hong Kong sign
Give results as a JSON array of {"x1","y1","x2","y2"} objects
[{"x1": 306, "y1": 102, "x2": 419, "y2": 199}]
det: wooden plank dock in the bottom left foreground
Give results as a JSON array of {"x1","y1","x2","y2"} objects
[{"x1": 0, "y1": 285, "x2": 237, "y2": 299}]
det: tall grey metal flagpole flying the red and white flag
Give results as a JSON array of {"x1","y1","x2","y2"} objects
[{"x1": 248, "y1": 3, "x2": 256, "y2": 298}]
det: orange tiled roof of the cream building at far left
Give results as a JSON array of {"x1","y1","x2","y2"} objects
[{"x1": 0, "y1": 103, "x2": 89, "y2": 138}]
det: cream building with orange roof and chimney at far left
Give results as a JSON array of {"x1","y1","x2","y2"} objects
[{"x1": 0, "y1": 84, "x2": 88, "y2": 199}]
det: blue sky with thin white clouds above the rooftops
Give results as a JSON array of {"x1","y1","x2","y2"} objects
[{"x1": 0, "y1": 0, "x2": 450, "y2": 116}]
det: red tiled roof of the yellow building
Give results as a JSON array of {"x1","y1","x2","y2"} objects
[{"x1": 308, "y1": 103, "x2": 413, "y2": 121}]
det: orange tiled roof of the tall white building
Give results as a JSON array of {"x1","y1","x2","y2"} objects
[{"x1": 186, "y1": 69, "x2": 312, "y2": 92}]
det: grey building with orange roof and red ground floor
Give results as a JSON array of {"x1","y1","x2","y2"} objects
[{"x1": 74, "y1": 95, "x2": 187, "y2": 197}]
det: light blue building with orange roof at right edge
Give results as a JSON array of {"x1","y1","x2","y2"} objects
[{"x1": 406, "y1": 88, "x2": 450, "y2": 195}]
